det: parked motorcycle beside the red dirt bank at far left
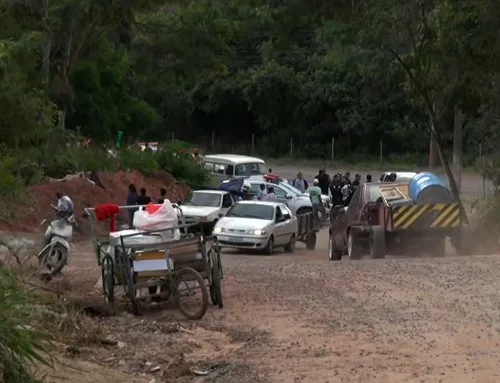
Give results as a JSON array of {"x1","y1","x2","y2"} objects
[{"x1": 38, "y1": 205, "x2": 77, "y2": 277}]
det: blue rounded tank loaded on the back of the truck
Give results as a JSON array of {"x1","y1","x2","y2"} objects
[{"x1": 408, "y1": 173, "x2": 453, "y2": 203}]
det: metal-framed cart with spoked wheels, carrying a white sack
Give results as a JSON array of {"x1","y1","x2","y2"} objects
[{"x1": 85, "y1": 206, "x2": 223, "y2": 319}]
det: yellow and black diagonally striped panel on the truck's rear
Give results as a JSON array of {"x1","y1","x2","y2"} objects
[{"x1": 392, "y1": 203, "x2": 461, "y2": 230}]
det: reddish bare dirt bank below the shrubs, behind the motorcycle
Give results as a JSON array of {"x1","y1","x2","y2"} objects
[{"x1": 0, "y1": 171, "x2": 189, "y2": 234}]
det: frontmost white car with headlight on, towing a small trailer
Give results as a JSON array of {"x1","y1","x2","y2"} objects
[{"x1": 213, "y1": 201, "x2": 298, "y2": 255}]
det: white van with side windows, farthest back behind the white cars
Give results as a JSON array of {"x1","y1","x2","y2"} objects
[{"x1": 203, "y1": 154, "x2": 269, "y2": 181}]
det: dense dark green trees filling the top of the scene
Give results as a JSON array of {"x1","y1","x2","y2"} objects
[{"x1": 0, "y1": 0, "x2": 500, "y2": 162}]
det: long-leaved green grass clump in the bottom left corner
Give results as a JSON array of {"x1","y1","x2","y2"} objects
[{"x1": 0, "y1": 267, "x2": 52, "y2": 383}]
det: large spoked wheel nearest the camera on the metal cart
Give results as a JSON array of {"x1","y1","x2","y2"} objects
[{"x1": 174, "y1": 267, "x2": 208, "y2": 319}]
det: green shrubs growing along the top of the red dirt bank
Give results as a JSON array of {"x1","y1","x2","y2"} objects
[{"x1": 0, "y1": 134, "x2": 208, "y2": 197}]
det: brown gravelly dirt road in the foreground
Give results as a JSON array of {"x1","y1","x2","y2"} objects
[{"x1": 42, "y1": 228, "x2": 500, "y2": 383}]
